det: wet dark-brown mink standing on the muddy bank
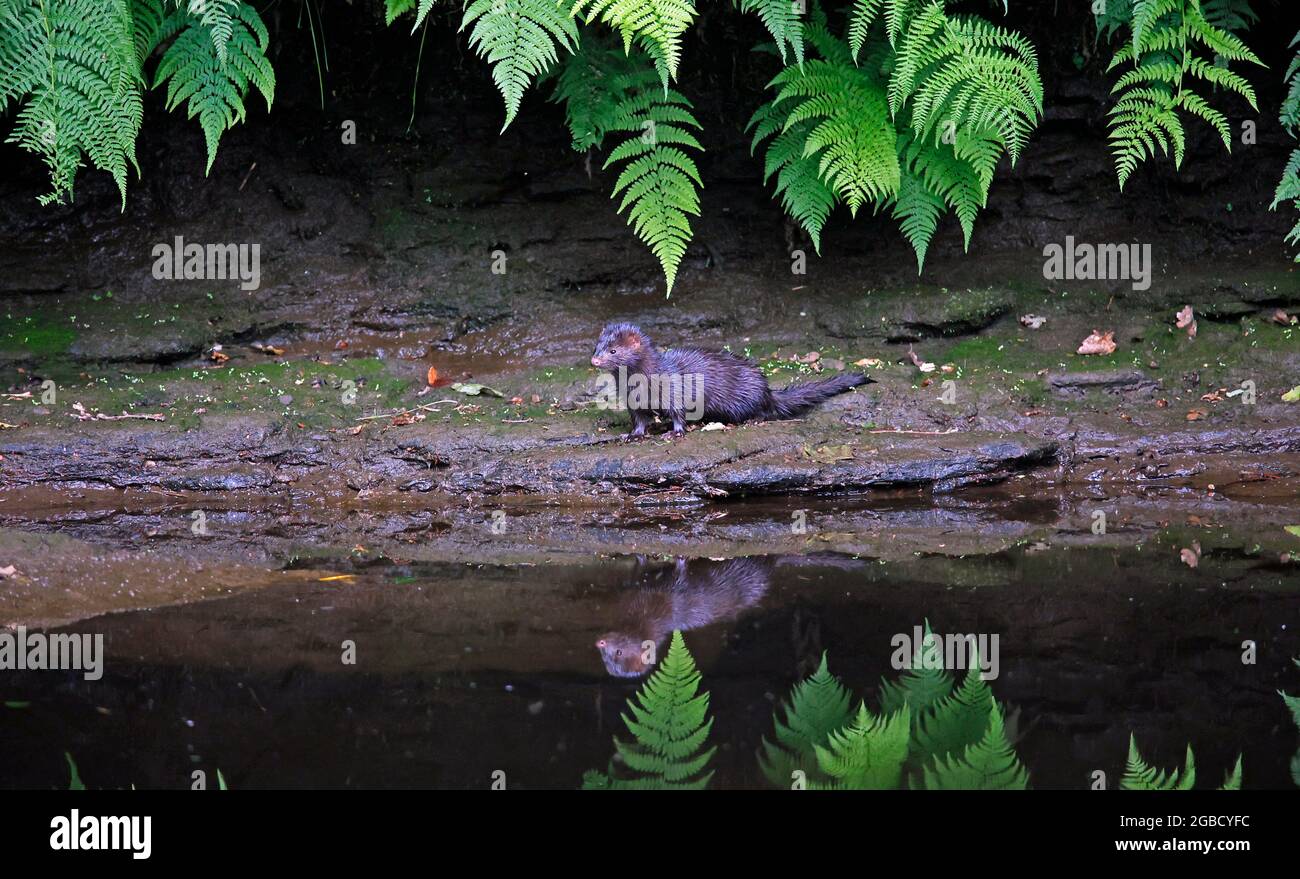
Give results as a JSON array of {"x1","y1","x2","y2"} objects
[{"x1": 592, "y1": 324, "x2": 875, "y2": 440}]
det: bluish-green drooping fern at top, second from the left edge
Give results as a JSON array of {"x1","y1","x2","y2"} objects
[{"x1": 153, "y1": 3, "x2": 276, "y2": 173}]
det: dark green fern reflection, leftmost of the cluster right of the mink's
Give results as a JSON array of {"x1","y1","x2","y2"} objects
[{"x1": 758, "y1": 653, "x2": 853, "y2": 788}]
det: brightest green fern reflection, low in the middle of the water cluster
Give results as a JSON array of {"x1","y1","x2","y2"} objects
[{"x1": 809, "y1": 703, "x2": 911, "y2": 791}]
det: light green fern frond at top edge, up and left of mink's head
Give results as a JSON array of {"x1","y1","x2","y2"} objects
[{"x1": 460, "y1": 0, "x2": 579, "y2": 131}]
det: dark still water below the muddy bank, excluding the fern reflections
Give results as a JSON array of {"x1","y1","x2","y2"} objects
[{"x1": 0, "y1": 527, "x2": 1300, "y2": 788}]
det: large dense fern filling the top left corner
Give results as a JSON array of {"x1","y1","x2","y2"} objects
[{"x1": 0, "y1": 0, "x2": 143, "y2": 209}]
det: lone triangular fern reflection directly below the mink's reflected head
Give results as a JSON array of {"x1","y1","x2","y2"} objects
[{"x1": 582, "y1": 632, "x2": 716, "y2": 791}]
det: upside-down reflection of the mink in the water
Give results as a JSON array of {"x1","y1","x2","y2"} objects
[{"x1": 595, "y1": 558, "x2": 775, "y2": 677}]
